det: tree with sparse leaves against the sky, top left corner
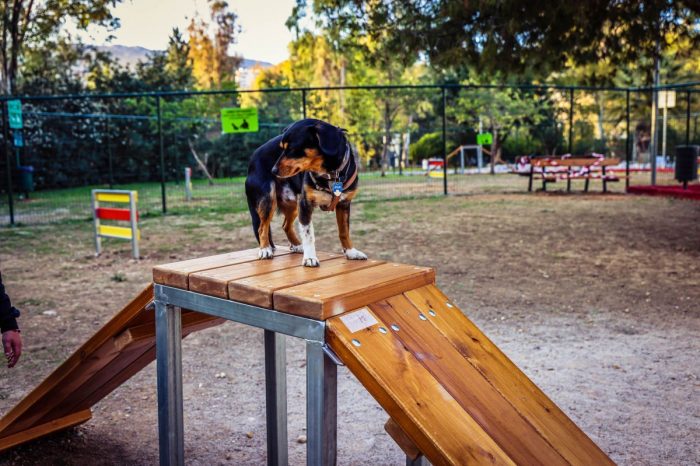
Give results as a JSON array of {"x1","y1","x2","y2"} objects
[{"x1": 0, "y1": 0, "x2": 121, "y2": 94}]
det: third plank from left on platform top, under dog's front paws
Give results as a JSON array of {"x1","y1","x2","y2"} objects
[{"x1": 228, "y1": 258, "x2": 385, "y2": 309}]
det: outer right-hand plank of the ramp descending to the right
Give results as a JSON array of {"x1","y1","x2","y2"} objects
[{"x1": 405, "y1": 285, "x2": 613, "y2": 465}]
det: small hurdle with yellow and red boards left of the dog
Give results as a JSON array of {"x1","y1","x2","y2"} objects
[{"x1": 92, "y1": 189, "x2": 141, "y2": 259}]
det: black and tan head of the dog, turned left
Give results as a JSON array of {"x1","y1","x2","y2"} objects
[{"x1": 272, "y1": 118, "x2": 347, "y2": 178}]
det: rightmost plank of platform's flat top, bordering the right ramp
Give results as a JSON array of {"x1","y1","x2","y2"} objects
[{"x1": 272, "y1": 263, "x2": 435, "y2": 320}]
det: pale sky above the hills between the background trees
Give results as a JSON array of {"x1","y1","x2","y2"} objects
[{"x1": 80, "y1": 0, "x2": 295, "y2": 64}]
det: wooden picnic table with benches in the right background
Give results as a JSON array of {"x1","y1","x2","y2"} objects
[{"x1": 519, "y1": 155, "x2": 624, "y2": 193}]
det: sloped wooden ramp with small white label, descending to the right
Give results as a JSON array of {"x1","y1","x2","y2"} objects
[{"x1": 326, "y1": 285, "x2": 613, "y2": 465}]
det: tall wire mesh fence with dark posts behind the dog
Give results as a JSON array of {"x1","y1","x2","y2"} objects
[{"x1": 0, "y1": 83, "x2": 700, "y2": 225}]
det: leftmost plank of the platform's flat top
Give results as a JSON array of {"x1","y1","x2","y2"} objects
[{"x1": 153, "y1": 248, "x2": 289, "y2": 290}]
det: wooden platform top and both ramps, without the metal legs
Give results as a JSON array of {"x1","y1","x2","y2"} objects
[{"x1": 0, "y1": 249, "x2": 613, "y2": 465}]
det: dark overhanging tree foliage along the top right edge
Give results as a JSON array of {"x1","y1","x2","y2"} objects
[{"x1": 298, "y1": 0, "x2": 700, "y2": 83}]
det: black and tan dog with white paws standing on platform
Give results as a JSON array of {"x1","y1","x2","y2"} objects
[{"x1": 245, "y1": 118, "x2": 367, "y2": 267}]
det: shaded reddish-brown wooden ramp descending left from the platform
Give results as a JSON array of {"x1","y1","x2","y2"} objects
[{"x1": 0, "y1": 285, "x2": 222, "y2": 452}]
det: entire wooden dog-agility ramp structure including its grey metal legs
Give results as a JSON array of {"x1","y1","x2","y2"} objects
[{"x1": 0, "y1": 249, "x2": 612, "y2": 465}]
